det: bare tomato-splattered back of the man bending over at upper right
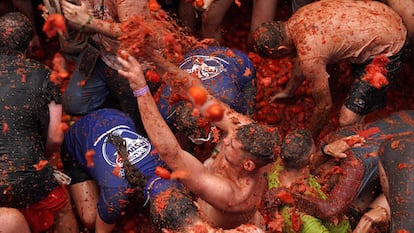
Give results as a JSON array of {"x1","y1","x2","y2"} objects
[{"x1": 287, "y1": 0, "x2": 407, "y2": 66}]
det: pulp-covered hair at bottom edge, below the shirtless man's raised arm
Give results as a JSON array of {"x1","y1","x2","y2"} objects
[{"x1": 150, "y1": 188, "x2": 198, "y2": 230}]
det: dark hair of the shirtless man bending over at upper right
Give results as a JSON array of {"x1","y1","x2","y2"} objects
[{"x1": 253, "y1": 21, "x2": 285, "y2": 57}]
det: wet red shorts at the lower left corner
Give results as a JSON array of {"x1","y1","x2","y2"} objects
[{"x1": 21, "y1": 186, "x2": 69, "y2": 233}]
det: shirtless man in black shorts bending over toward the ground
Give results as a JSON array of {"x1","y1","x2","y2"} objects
[{"x1": 254, "y1": 0, "x2": 407, "y2": 137}]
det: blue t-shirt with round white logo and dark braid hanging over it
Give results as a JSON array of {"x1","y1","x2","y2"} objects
[{"x1": 64, "y1": 109, "x2": 181, "y2": 224}]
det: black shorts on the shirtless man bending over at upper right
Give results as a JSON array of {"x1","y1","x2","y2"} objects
[{"x1": 344, "y1": 42, "x2": 409, "y2": 115}]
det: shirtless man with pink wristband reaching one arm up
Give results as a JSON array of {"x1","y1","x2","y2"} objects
[{"x1": 118, "y1": 54, "x2": 279, "y2": 229}]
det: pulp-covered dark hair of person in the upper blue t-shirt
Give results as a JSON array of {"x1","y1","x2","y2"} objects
[{"x1": 175, "y1": 101, "x2": 211, "y2": 138}]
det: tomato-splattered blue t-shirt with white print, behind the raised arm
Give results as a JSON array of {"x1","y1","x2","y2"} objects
[{"x1": 158, "y1": 47, "x2": 256, "y2": 126}]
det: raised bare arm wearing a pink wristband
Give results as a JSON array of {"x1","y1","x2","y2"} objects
[{"x1": 118, "y1": 52, "x2": 254, "y2": 211}]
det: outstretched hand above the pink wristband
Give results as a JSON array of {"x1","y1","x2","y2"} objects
[{"x1": 117, "y1": 51, "x2": 147, "y2": 90}]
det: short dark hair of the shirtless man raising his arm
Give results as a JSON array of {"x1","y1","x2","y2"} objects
[{"x1": 236, "y1": 123, "x2": 279, "y2": 165}]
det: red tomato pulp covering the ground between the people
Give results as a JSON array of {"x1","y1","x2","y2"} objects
[{"x1": 33, "y1": 0, "x2": 414, "y2": 233}]
